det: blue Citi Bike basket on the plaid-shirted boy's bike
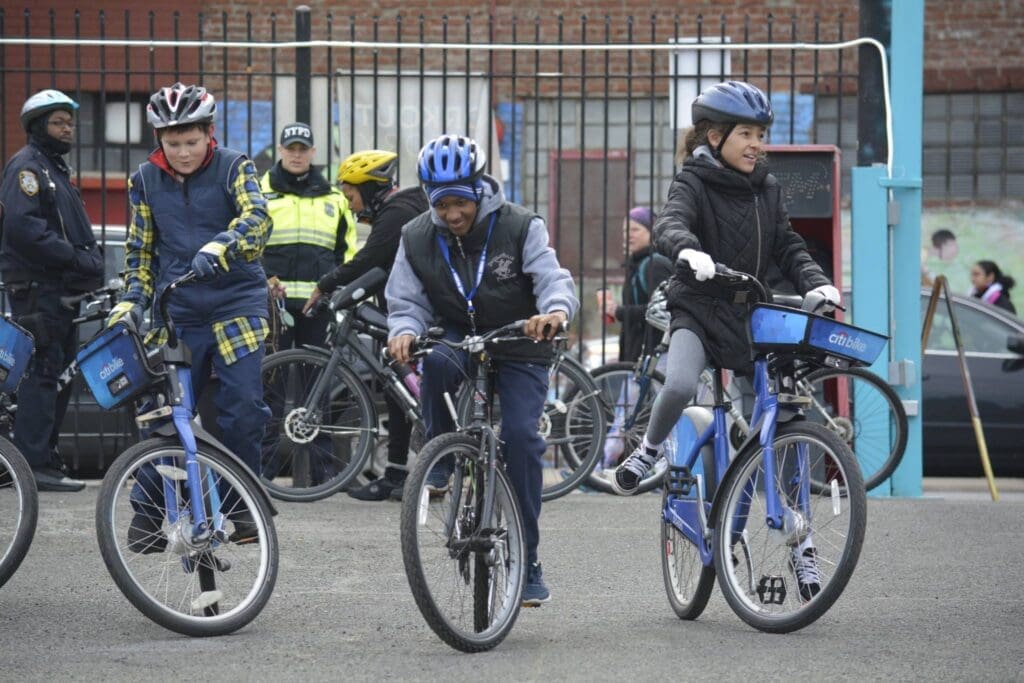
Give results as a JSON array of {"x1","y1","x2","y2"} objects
[{"x1": 78, "y1": 323, "x2": 160, "y2": 410}]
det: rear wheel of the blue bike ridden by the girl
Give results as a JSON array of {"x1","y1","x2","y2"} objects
[{"x1": 662, "y1": 488, "x2": 715, "y2": 621}]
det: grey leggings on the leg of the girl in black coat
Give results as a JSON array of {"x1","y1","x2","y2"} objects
[{"x1": 647, "y1": 330, "x2": 708, "y2": 445}]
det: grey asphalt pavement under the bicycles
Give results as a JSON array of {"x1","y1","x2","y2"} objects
[{"x1": 0, "y1": 480, "x2": 1024, "y2": 681}]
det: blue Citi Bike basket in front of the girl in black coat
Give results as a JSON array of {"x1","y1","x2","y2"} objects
[{"x1": 751, "y1": 304, "x2": 889, "y2": 366}]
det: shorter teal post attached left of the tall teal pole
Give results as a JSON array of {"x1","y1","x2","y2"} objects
[{"x1": 850, "y1": 164, "x2": 892, "y2": 496}]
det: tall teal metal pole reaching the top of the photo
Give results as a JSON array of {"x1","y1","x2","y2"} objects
[{"x1": 884, "y1": 0, "x2": 925, "y2": 496}]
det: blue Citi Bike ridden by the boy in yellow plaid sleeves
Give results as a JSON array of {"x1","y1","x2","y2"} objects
[{"x1": 78, "y1": 272, "x2": 278, "y2": 636}]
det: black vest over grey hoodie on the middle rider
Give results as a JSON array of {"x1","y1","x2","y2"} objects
[{"x1": 402, "y1": 204, "x2": 552, "y2": 362}]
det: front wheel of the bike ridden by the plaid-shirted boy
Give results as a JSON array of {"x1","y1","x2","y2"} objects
[{"x1": 96, "y1": 438, "x2": 278, "y2": 636}]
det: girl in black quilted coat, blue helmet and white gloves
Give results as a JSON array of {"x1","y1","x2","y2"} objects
[{"x1": 612, "y1": 81, "x2": 840, "y2": 495}]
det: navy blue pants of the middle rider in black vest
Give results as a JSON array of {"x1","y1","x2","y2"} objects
[{"x1": 421, "y1": 335, "x2": 548, "y2": 563}]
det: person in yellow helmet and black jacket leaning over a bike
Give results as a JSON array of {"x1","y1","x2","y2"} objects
[{"x1": 303, "y1": 150, "x2": 430, "y2": 501}]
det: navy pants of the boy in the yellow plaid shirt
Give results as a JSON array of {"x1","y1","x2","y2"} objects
[{"x1": 131, "y1": 327, "x2": 270, "y2": 517}]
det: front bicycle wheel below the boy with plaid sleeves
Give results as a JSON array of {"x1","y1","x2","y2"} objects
[{"x1": 96, "y1": 437, "x2": 279, "y2": 637}]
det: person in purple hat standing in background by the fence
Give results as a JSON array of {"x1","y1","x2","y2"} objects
[{"x1": 597, "y1": 206, "x2": 674, "y2": 361}]
